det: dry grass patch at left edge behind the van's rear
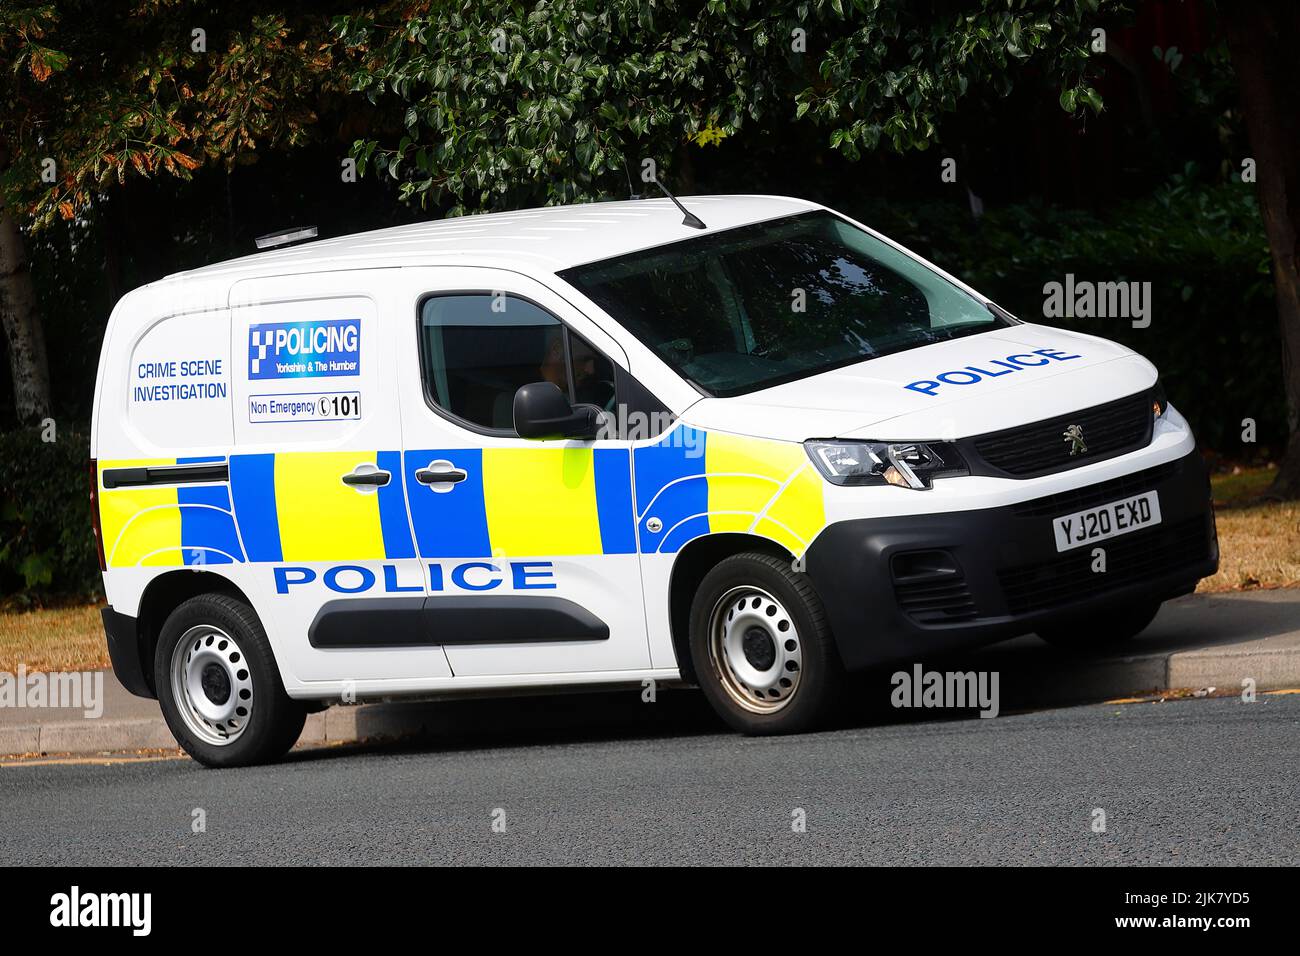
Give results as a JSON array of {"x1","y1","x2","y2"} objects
[{"x1": 0, "y1": 605, "x2": 108, "y2": 674}]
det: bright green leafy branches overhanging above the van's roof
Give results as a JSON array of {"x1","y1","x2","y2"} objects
[{"x1": 334, "y1": 0, "x2": 1122, "y2": 212}]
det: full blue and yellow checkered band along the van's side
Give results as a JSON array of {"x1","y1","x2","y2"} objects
[{"x1": 100, "y1": 425, "x2": 826, "y2": 567}]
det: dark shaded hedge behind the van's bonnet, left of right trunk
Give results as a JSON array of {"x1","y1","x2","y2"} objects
[{"x1": 861, "y1": 176, "x2": 1287, "y2": 460}]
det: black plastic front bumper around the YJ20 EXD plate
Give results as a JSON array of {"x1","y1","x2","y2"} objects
[{"x1": 806, "y1": 451, "x2": 1218, "y2": 670}]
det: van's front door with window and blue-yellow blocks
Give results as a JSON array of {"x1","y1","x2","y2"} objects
[{"x1": 395, "y1": 267, "x2": 650, "y2": 680}]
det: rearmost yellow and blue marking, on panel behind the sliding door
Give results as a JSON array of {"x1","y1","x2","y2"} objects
[{"x1": 99, "y1": 458, "x2": 244, "y2": 567}]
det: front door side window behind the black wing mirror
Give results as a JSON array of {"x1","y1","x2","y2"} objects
[{"x1": 420, "y1": 293, "x2": 615, "y2": 431}]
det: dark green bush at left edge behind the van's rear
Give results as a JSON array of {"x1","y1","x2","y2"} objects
[{"x1": 0, "y1": 428, "x2": 100, "y2": 604}]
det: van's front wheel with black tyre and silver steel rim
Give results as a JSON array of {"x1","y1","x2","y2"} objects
[{"x1": 690, "y1": 553, "x2": 844, "y2": 735}]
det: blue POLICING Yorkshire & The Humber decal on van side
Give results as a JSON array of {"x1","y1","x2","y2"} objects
[{"x1": 248, "y1": 319, "x2": 361, "y2": 378}]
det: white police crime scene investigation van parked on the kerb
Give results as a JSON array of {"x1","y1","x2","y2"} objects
[{"x1": 91, "y1": 196, "x2": 1218, "y2": 766}]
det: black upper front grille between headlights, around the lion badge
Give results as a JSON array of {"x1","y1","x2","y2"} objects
[{"x1": 970, "y1": 392, "x2": 1154, "y2": 477}]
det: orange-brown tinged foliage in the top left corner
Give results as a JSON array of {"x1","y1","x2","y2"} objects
[{"x1": 0, "y1": 0, "x2": 342, "y2": 226}]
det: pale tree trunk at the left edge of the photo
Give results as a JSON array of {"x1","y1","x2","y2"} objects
[{"x1": 0, "y1": 196, "x2": 49, "y2": 421}]
